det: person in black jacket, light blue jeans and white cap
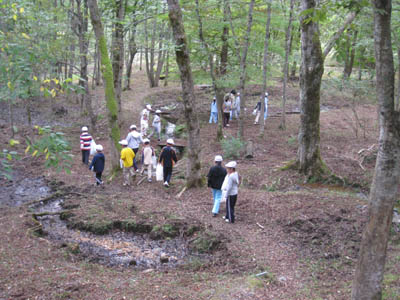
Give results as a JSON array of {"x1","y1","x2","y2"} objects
[{"x1": 207, "y1": 155, "x2": 226, "y2": 217}]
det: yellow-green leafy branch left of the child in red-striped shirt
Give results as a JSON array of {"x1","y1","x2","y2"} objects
[{"x1": 25, "y1": 126, "x2": 73, "y2": 173}]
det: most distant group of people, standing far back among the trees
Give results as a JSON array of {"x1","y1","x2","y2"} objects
[{"x1": 209, "y1": 90, "x2": 268, "y2": 127}]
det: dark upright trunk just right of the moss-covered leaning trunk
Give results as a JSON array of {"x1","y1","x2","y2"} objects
[{"x1": 112, "y1": 0, "x2": 126, "y2": 113}]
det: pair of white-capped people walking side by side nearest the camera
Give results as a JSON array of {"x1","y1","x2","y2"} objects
[{"x1": 207, "y1": 155, "x2": 240, "y2": 223}]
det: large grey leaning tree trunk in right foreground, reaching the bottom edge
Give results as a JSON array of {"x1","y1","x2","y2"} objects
[{"x1": 351, "y1": 0, "x2": 400, "y2": 300}]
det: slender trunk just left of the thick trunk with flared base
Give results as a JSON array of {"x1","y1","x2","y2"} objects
[{"x1": 279, "y1": 0, "x2": 294, "y2": 130}]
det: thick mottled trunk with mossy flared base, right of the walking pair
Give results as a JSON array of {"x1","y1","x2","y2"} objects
[{"x1": 297, "y1": 0, "x2": 325, "y2": 178}]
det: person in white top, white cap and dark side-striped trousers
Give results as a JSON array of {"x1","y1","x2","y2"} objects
[{"x1": 223, "y1": 161, "x2": 240, "y2": 223}]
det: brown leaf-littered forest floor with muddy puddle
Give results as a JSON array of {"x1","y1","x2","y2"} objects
[{"x1": 0, "y1": 73, "x2": 400, "y2": 300}]
